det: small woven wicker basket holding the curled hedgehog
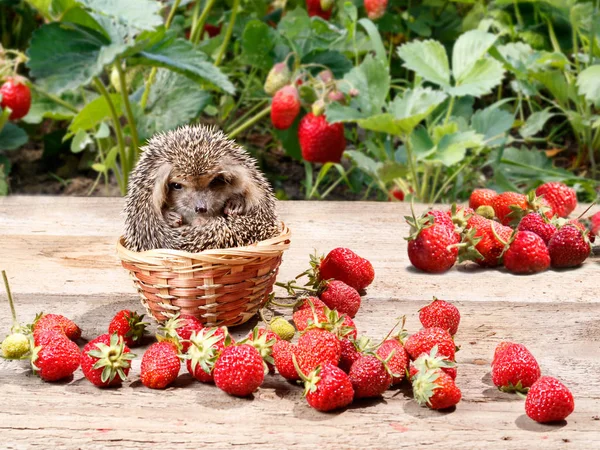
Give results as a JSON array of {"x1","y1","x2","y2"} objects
[{"x1": 117, "y1": 224, "x2": 291, "y2": 326}]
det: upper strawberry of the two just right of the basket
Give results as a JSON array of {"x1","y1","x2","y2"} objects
[{"x1": 312, "y1": 247, "x2": 375, "y2": 292}]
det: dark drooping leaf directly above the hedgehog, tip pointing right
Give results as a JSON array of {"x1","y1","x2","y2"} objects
[{"x1": 129, "y1": 34, "x2": 235, "y2": 94}]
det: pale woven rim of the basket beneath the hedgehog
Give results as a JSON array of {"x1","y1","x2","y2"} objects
[{"x1": 117, "y1": 222, "x2": 292, "y2": 264}]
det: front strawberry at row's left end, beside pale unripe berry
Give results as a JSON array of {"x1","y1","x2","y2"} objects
[{"x1": 31, "y1": 330, "x2": 81, "y2": 381}]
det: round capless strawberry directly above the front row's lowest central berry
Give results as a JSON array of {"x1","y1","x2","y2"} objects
[{"x1": 296, "y1": 328, "x2": 342, "y2": 373}]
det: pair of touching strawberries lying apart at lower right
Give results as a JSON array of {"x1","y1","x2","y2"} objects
[{"x1": 492, "y1": 342, "x2": 575, "y2": 423}]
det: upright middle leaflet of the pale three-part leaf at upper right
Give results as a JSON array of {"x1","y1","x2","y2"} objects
[{"x1": 452, "y1": 30, "x2": 496, "y2": 81}]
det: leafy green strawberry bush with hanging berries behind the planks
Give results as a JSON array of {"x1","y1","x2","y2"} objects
[{"x1": 0, "y1": 0, "x2": 600, "y2": 202}]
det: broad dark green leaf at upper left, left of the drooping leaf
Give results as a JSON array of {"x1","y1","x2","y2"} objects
[{"x1": 27, "y1": 23, "x2": 127, "y2": 94}]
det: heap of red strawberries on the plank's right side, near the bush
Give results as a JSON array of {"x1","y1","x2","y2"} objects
[{"x1": 406, "y1": 182, "x2": 600, "y2": 274}]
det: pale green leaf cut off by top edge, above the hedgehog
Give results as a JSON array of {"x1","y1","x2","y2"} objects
[{"x1": 79, "y1": 0, "x2": 163, "y2": 30}]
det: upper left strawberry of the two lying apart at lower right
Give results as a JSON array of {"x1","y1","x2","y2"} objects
[{"x1": 492, "y1": 344, "x2": 541, "y2": 392}]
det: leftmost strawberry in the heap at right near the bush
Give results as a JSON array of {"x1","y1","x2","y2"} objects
[{"x1": 405, "y1": 209, "x2": 460, "y2": 273}]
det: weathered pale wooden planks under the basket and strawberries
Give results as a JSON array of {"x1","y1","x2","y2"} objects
[{"x1": 0, "y1": 197, "x2": 600, "y2": 449}]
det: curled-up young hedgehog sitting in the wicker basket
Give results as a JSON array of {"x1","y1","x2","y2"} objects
[{"x1": 124, "y1": 125, "x2": 280, "y2": 252}]
